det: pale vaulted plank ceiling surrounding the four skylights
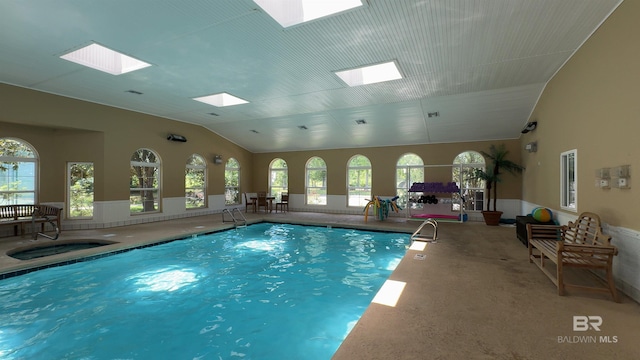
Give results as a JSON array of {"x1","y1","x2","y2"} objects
[{"x1": 0, "y1": 0, "x2": 621, "y2": 152}]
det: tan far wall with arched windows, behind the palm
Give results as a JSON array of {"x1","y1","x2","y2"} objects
[{"x1": 253, "y1": 140, "x2": 522, "y2": 199}]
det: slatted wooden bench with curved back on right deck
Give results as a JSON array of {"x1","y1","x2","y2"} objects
[{"x1": 527, "y1": 212, "x2": 620, "y2": 302}]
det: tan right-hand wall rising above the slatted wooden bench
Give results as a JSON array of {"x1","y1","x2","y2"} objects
[{"x1": 522, "y1": 1, "x2": 640, "y2": 230}]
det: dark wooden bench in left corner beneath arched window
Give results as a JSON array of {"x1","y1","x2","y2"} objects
[{"x1": 0, "y1": 204, "x2": 62, "y2": 236}]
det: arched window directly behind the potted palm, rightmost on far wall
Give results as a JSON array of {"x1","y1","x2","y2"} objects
[{"x1": 451, "y1": 151, "x2": 485, "y2": 211}]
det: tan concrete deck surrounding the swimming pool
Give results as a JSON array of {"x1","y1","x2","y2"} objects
[{"x1": 0, "y1": 212, "x2": 640, "y2": 360}]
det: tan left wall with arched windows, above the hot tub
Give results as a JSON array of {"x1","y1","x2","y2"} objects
[{"x1": 0, "y1": 84, "x2": 253, "y2": 202}]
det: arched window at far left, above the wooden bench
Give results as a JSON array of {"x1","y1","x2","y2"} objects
[{"x1": 0, "y1": 138, "x2": 38, "y2": 205}]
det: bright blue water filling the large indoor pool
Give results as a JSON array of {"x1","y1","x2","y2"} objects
[{"x1": 0, "y1": 223, "x2": 409, "y2": 360}]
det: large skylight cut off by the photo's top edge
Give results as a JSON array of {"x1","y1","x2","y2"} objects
[{"x1": 253, "y1": 0, "x2": 362, "y2": 28}]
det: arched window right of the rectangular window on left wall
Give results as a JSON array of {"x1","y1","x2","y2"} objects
[{"x1": 129, "y1": 149, "x2": 160, "y2": 214}]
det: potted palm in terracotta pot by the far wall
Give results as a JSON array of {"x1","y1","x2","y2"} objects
[{"x1": 472, "y1": 144, "x2": 524, "y2": 226}]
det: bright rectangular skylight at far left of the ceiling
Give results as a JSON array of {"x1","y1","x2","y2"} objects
[{"x1": 60, "y1": 43, "x2": 151, "y2": 75}]
